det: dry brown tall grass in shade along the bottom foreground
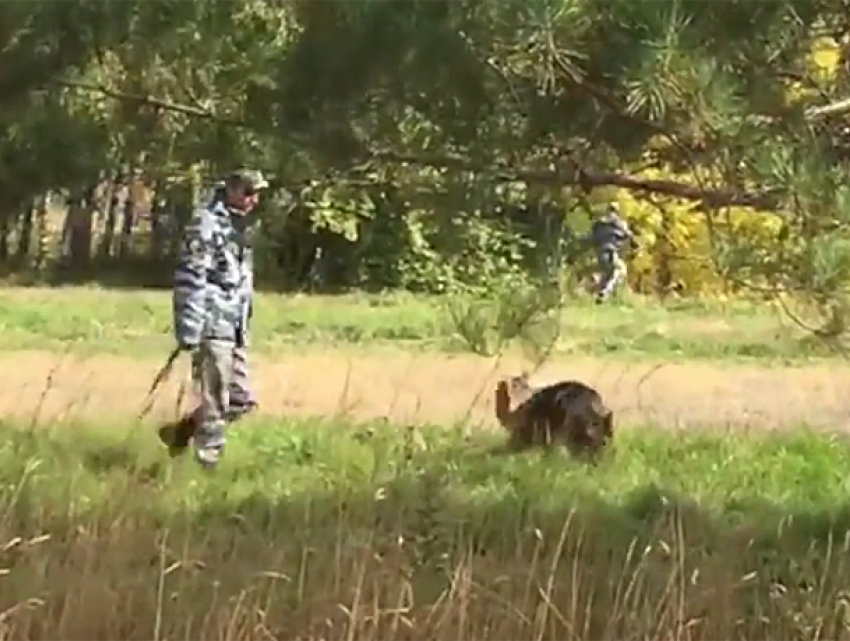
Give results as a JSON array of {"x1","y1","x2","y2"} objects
[{"x1": 0, "y1": 498, "x2": 850, "y2": 640}]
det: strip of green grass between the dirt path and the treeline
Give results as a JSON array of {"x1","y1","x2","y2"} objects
[{"x1": 0, "y1": 287, "x2": 826, "y2": 361}]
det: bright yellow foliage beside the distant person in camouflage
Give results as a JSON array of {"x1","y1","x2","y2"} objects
[{"x1": 588, "y1": 169, "x2": 782, "y2": 295}]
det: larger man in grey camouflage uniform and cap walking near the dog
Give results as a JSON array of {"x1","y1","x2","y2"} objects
[{"x1": 160, "y1": 170, "x2": 268, "y2": 467}]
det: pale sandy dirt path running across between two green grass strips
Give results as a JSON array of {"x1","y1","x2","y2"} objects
[{"x1": 0, "y1": 349, "x2": 850, "y2": 430}]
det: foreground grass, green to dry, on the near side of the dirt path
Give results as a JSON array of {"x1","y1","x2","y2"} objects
[{"x1": 0, "y1": 417, "x2": 850, "y2": 639}]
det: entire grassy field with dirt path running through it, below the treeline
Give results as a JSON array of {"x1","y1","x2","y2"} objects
[{"x1": 0, "y1": 289, "x2": 850, "y2": 640}]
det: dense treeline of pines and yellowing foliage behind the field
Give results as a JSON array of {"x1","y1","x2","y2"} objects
[{"x1": 0, "y1": 0, "x2": 850, "y2": 309}]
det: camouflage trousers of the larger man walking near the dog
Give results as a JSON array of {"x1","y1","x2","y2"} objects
[{"x1": 192, "y1": 339, "x2": 255, "y2": 467}]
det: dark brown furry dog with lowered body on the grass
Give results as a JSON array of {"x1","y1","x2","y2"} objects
[{"x1": 495, "y1": 374, "x2": 614, "y2": 459}]
